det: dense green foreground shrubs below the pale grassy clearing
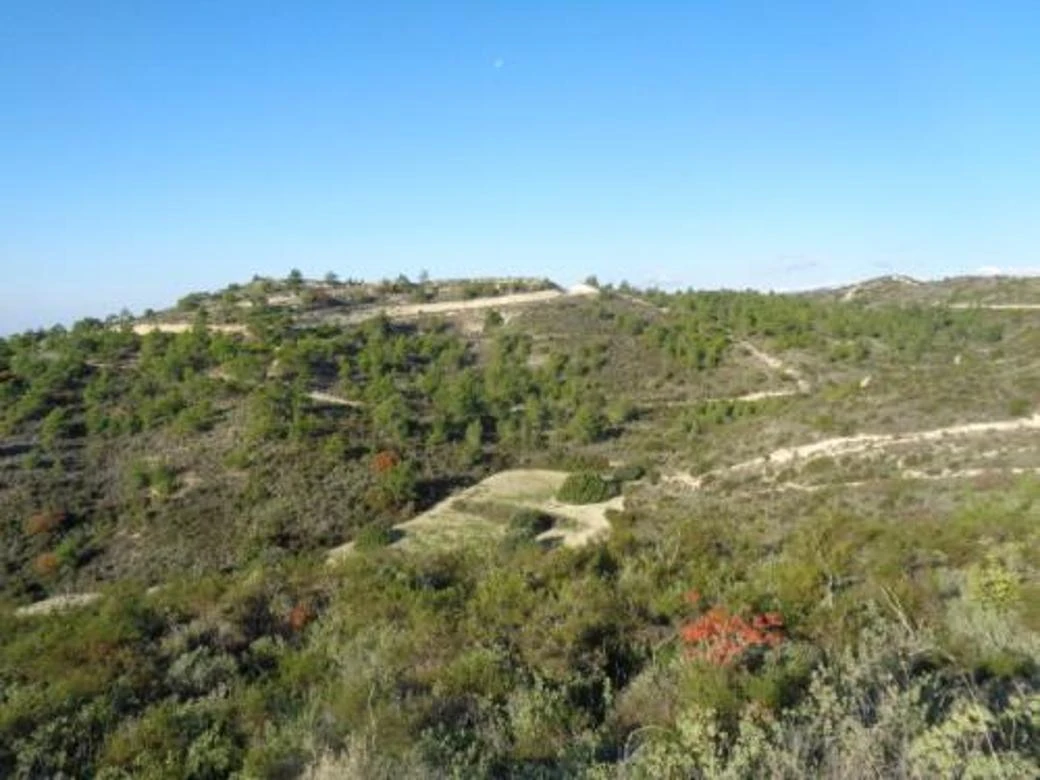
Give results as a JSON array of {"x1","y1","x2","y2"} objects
[{"x1": 10, "y1": 476, "x2": 1040, "y2": 778}]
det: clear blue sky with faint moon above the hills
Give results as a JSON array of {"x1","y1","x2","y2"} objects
[{"x1": 0, "y1": 0, "x2": 1040, "y2": 332}]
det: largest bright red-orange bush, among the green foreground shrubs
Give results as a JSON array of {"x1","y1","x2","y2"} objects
[{"x1": 679, "y1": 591, "x2": 784, "y2": 666}]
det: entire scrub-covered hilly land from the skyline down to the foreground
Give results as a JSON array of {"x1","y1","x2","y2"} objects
[{"x1": 0, "y1": 272, "x2": 1040, "y2": 778}]
